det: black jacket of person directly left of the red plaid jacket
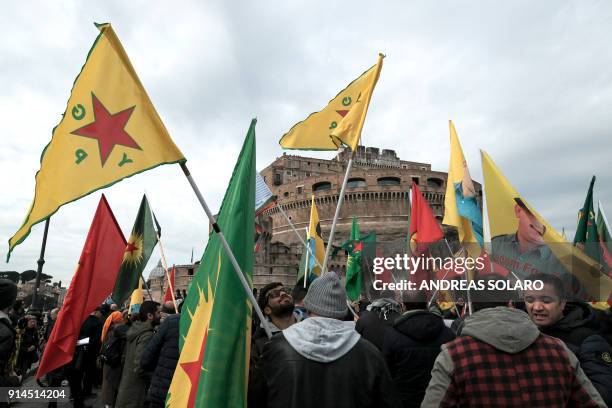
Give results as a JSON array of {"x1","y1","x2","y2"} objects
[{"x1": 383, "y1": 310, "x2": 455, "y2": 407}]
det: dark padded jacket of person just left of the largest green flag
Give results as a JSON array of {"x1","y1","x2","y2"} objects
[{"x1": 140, "y1": 314, "x2": 181, "y2": 406}]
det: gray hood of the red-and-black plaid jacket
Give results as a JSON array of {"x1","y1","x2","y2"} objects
[{"x1": 459, "y1": 307, "x2": 540, "y2": 354}]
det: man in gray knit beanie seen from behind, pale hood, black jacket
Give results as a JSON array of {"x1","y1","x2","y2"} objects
[{"x1": 263, "y1": 272, "x2": 401, "y2": 408}]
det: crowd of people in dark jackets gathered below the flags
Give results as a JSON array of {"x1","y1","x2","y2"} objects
[{"x1": 0, "y1": 272, "x2": 612, "y2": 408}]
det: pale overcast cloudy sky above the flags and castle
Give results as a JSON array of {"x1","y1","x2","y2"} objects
[{"x1": 0, "y1": 0, "x2": 612, "y2": 283}]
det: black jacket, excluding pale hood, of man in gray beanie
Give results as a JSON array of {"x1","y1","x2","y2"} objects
[{"x1": 263, "y1": 334, "x2": 399, "y2": 408}]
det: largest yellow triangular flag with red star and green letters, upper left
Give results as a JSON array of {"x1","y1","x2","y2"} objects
[{"x1": 7, "y1": 24, "x2": 185, "y2": 260}]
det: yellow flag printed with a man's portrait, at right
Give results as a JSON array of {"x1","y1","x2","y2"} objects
[{"x1": 481, "y1": 151, "x2": 612, "y2": 301}]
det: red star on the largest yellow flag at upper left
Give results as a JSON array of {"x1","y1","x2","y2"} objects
[{"x1": 72, "y1": 92, "x2": 142, "y2": 167}]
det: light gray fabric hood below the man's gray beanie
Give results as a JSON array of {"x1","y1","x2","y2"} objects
[{"x1": 283, "y1": 317, "x2": 361, "y2": 363}]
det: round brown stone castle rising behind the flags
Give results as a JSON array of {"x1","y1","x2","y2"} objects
[{"x1": 150, "y1": 146, "x2": 482, "y2": 299}]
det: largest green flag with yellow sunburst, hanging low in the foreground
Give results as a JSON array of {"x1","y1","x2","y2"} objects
[{"x1": 166, "y1": 119, "x2": 256, "y2": 408}]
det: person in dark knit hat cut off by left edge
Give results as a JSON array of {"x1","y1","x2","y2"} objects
[{"x1": 0, "y1": 279, "x2": 17, "y2": 387}]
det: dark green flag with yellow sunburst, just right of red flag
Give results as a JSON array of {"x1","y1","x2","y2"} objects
[{"x1": 111, "y1": 195, "x2": 159, "y2": 305}]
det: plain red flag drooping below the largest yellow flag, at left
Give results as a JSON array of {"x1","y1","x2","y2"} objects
[{"x1": 36, "y1": 194, "x2": 127, "y2": 379}]
